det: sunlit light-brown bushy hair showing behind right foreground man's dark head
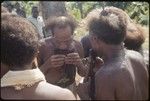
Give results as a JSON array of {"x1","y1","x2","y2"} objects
[{"x1": 85, "y1": 7, "x2": 145, "y2": 52}]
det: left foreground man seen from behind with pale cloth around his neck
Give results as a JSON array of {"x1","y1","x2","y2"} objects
[{"x1": 1, "y1": 13, "x2": 75, "y2": 100}]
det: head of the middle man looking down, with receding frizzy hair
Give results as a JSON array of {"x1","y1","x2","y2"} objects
[{"x1": 46, "y1": 16, "x2": 76, "y2": 49}]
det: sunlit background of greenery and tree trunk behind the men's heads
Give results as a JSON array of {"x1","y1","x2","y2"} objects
[{"x1": 1, "y1": 1, "x2": 149, "y2": 68}]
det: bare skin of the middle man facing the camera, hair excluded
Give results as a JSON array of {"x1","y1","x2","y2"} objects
[{"x1": 38, "y1": 26, "x2": 86, "y2": 84}]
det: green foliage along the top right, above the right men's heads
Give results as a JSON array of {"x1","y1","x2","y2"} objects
[{"x1": 66, "y1": 1, "x2": 149, "y2": 25}]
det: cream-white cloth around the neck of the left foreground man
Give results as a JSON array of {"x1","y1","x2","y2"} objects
[{"x1": 1, "y1": 68, "x2": 46, "y2": 90}]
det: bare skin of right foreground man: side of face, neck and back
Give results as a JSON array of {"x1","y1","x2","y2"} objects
[{"x1": 91, "y1": 36, "x2": 149, "y2": 100}]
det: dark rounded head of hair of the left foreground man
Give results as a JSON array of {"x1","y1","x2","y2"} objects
[{"x1": 1, "y1": 13, "x2": 38, "y2": 69}]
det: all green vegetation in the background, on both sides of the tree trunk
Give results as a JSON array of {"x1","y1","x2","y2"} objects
[{"x1": 3, "y1": 1, "x2": 149, "y2": 47}]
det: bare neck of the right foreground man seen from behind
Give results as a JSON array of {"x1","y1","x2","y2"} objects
[{"x1": 102, "y1": 44, "x2": 125, "y2": 62}]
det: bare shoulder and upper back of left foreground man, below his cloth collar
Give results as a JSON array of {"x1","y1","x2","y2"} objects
[{"x1": 1, "y1": 59, "x2": 75, "y2": 100}]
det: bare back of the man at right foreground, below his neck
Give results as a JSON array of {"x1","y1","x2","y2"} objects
[{"x1": 96, "y1": 51, "x2": 148, "y2": 100}]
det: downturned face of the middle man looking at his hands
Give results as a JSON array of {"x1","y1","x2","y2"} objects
[{"x1": 53, "y1": 26, "x2": 73, "y2": 50}]
